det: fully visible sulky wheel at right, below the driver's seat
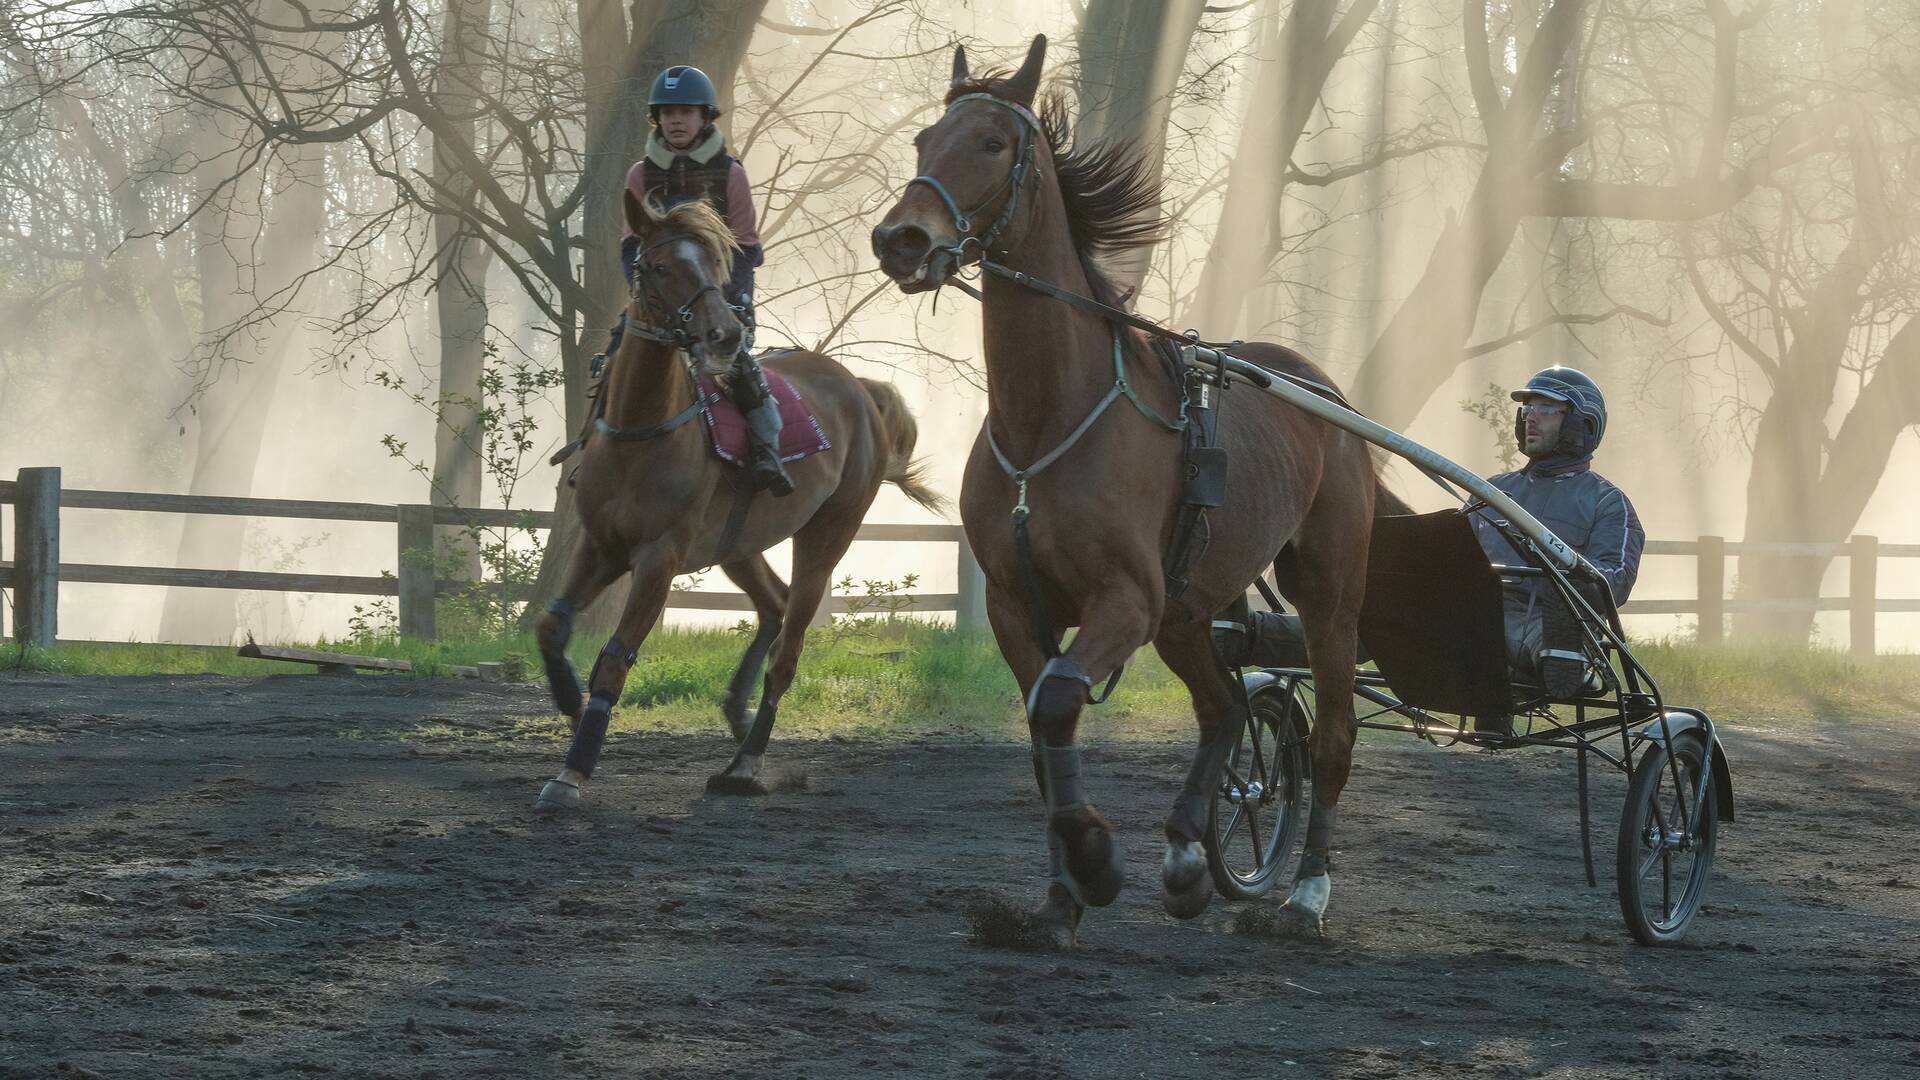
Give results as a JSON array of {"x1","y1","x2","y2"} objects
[{"x1": 1615, "y1": 730, "x2": 1720, "y2": 945}]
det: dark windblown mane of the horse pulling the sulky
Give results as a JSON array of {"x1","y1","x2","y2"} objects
[{"x1": 947, "y1": 71, "x2": 1167, "y2": 306}]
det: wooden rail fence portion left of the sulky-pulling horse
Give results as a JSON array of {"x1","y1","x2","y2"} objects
[{"x1": 0, "y1": 469, "x2": 987, "y2": 648}]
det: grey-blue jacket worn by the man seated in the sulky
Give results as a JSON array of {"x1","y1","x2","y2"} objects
[{"x1": 1473, "y1": 469, "x2": 1647, "y2": 603}]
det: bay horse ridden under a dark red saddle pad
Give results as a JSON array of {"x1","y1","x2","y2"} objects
[{"x1": 536, "y1": 192, "x2": 945, "y2": 809}]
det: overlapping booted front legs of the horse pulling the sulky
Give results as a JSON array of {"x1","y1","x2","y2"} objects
[{"x1": 987, "y1": 598, "x2": 1150, "y2": 922}]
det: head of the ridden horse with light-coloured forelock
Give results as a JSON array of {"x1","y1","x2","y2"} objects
[{"x1": 626, "y1": 192, "x2": 745, "y2": 375}]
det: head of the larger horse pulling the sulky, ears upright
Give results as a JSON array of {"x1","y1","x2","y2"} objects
[{"x1": 874, "y1": 35, "x2": 1046, "y2": 292}]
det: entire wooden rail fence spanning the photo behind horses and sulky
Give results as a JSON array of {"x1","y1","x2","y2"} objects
[{"x1": 0, "y1": 469, "x2": 1920, "y2": 655}]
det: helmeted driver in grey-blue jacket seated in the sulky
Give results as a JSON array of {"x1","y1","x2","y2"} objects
[{"x1": 1217, "y1": 367, "x2": 1647, "y2": 707}]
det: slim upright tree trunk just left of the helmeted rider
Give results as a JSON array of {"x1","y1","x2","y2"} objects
[{"x1": 430, "y1": 0, "x2": 493, "y2": 580}]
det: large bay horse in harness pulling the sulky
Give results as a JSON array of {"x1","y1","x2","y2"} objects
[{"x1": 872, "y1": 37, "x2": 1405, "y2": 945}]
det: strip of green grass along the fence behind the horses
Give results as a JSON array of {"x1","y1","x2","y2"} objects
[{"x1": 11, "y1": 623, "x2": 1920, "y2": 738}]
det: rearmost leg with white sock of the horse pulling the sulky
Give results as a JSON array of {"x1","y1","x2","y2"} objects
[{"x1": 1281, "y1": 549, "x2": 1365, "y2": 934}]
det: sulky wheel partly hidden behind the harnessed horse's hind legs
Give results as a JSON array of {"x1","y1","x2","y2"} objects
[{"x1": 1204, "y1": 676, "x2": 1313, "y2": 899}]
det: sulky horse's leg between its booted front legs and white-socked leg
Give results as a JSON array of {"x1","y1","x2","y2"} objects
[{"x1": 1154, "y1": 623, "x2": 1246, "y2": 919}]
